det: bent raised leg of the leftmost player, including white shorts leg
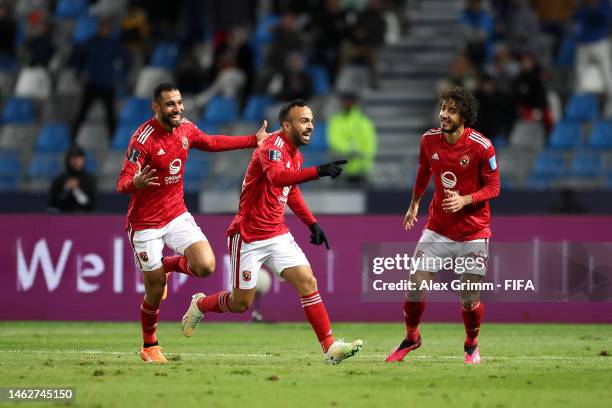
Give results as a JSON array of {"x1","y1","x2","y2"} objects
[{"x1": 162, "y1": 213, "x2": 215, "y2": 278}]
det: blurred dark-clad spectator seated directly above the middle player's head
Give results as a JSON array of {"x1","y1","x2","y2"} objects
[{"x1": 273, "y1": 52, "x2": 313, "y2": 102}]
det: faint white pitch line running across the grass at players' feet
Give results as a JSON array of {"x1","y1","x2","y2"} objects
[{"x1": 0, "y1": 349, "x2": 612, "y2": 361}]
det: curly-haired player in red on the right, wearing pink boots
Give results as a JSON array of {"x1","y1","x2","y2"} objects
[{"x1": 385, "y1": 86, "x2": 499, "y2": 364}]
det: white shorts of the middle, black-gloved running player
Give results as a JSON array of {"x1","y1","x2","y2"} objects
[{"x1": 228, "y1": 232, "x2": 310, "y2": 289}]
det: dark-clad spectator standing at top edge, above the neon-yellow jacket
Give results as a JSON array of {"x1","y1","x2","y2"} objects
[{"x1": 340, "y1": 0, "x2": 387, "y2": 89}]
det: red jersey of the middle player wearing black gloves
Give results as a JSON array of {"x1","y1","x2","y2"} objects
[{"x1": 227, "y1": 132, "x2": 318, "y2": 242}]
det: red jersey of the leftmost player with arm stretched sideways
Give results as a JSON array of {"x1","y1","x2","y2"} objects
[{"x1": 117, "y1": 117, "x2": 257, "y2": 231}]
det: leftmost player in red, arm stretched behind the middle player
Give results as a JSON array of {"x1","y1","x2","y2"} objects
[{"x1": 117, "y1": 83, "x2": 269, "y2": 363}]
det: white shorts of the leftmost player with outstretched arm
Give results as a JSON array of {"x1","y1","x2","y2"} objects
[{"x1": 128, "y1": 212, "x2": 208, "y2": 272}]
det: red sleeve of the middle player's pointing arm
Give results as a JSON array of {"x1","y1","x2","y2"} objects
[{"x1": 257, "y1": 146, "x2": 319, "y2": 187}]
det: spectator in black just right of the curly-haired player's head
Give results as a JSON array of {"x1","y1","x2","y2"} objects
[{"x1": 474, "y1": 74, "x2": 515, "y2": 139}]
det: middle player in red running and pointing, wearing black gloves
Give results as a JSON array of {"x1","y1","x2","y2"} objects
[{"x1": 182, "y1": 100, "x2": 363, "y2": 364}]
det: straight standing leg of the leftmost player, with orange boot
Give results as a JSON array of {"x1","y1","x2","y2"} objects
[{"x1": 130, "y1": 230, "x2": 167, "y2": 363}]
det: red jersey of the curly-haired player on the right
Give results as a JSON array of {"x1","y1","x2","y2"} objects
[{"x1": 414, "y1": 128, "x2": 499, "y2": 241}]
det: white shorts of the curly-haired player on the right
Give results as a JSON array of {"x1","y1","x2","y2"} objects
[{"x1": 414, "y1": 228, "x2": 489, "y2": 275}]
